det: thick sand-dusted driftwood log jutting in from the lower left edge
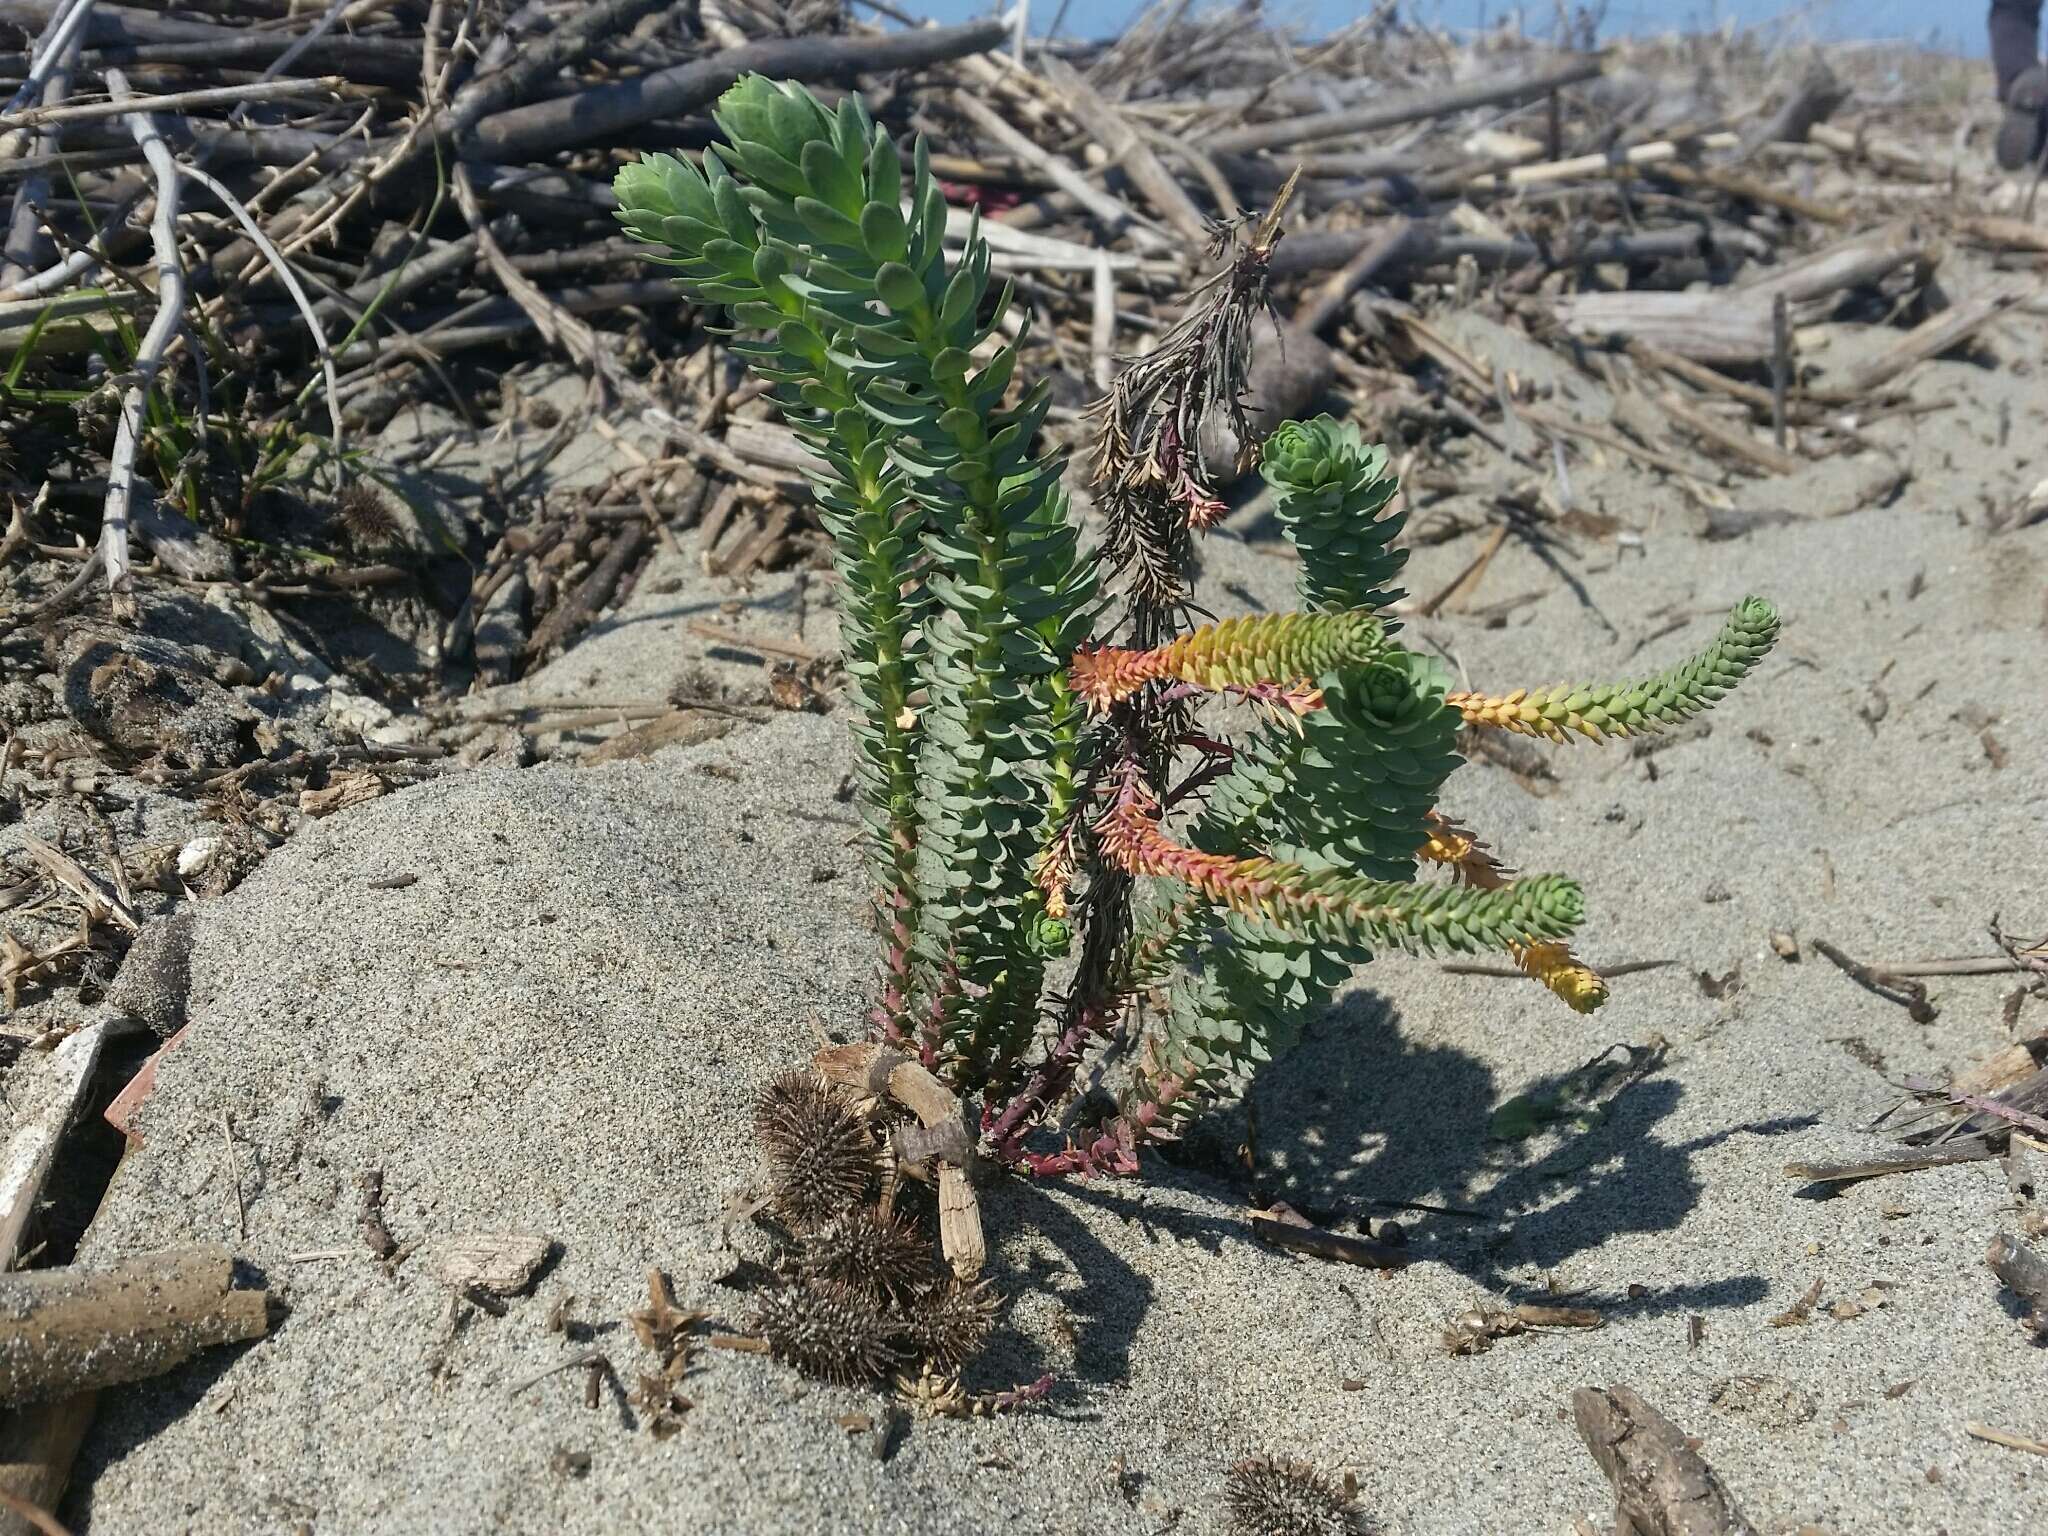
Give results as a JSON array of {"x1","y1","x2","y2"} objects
[{"x1": 0, "y1": 1245, "x2": 270, "y2": 1405}]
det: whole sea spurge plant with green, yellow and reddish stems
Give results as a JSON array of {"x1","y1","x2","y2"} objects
[{"x1": 616, "y1": 78, "x2": 1778, "y2": 1187}]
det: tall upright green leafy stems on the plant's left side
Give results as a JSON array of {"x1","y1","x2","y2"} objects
[{"x1": 616, "y1": 76, "x2": 1094, "y2": 1077}]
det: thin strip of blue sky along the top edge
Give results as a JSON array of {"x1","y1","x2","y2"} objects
[{"x1": 897, "y1": 0, "x2": 1985, "y2": 53}]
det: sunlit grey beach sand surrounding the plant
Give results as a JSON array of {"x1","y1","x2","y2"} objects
[{"x1": 48, "y1": 282, "x2": 2048, "y2": 1536}]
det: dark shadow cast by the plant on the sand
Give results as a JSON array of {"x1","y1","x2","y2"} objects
[{"x1": 1010, "y1": 991, "x2": 1815, "y2": 1380}]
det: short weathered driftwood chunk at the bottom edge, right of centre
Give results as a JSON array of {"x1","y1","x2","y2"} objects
[{"x1": 1571, "y1": 1386, "x2": 1757, "y2": 1536}]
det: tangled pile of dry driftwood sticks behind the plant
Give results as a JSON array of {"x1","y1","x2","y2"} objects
[{"x1": 0, "y1": 0, "x2": 2048, "y2": 684}]
